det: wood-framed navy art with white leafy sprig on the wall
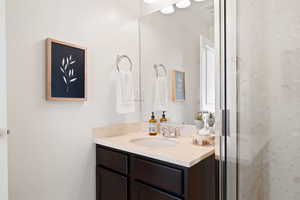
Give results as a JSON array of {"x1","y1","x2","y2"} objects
[{"x1": 46, "y1": 38, "x2": 87, "y2": 101}]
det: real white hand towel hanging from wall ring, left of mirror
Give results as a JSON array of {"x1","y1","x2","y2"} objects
[{"x1": 116, "y1": 71, "x2": 135, "y2": 114}]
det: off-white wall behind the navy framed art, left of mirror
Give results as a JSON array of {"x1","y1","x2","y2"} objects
[{"x1": 6, "y1": 0, "x2": 139, "y2": 200}]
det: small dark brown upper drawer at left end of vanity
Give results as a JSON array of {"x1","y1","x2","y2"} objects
[{"x1": 96, "y1": 146, "x2": 128, "y2": 175}]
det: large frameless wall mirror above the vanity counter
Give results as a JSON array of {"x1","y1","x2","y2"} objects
[{"x1": 140, "y1": 0, "x2": 216, "y2": 124}]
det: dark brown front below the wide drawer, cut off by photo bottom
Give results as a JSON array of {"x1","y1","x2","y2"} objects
[{"x1": 131, "y1": 181, "x2": 180, "y2": 200}]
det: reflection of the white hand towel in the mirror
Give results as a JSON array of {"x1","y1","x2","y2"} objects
[{"x1": 154, "y1": 76, "x2": 169, "y2": 111}]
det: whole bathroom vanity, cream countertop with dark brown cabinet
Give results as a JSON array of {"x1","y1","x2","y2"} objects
[{"x1": 95, "y1": 133, "x2": 216, "y2": 200}]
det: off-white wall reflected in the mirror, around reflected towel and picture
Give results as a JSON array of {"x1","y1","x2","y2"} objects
[{"x1": 141, "y1": 4, "x2": 213, "y2": 124}]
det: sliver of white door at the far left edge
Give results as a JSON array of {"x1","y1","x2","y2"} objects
[{"x1": 0, "y1": 0, "x2": 8, "y2": 200}]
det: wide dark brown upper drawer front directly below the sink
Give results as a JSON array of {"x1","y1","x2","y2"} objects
[{"x1": 130, "y1": 157, "x2": 183, "y2": 195}]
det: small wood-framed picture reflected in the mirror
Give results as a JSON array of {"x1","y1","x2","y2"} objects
[{"x1": 172, "y1": 70, "x2": 185, "y2": 101}]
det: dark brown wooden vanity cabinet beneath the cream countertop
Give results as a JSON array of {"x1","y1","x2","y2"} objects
[{"x1": 96, "y1": 145, "x2": 215, "y2": 200}]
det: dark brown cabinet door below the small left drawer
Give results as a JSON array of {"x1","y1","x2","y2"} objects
[{"x1": 96, "y1": 167, "x2": 127, "y2": 200}]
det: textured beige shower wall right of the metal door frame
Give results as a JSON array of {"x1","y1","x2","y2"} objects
[{"x1": 238, "y1": 0, "x2": 300, "y2": 200}]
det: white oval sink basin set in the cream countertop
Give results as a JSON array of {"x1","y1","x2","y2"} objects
[{"x1": 130, "y1": 138, "x2": 178, "y2": 148}]
